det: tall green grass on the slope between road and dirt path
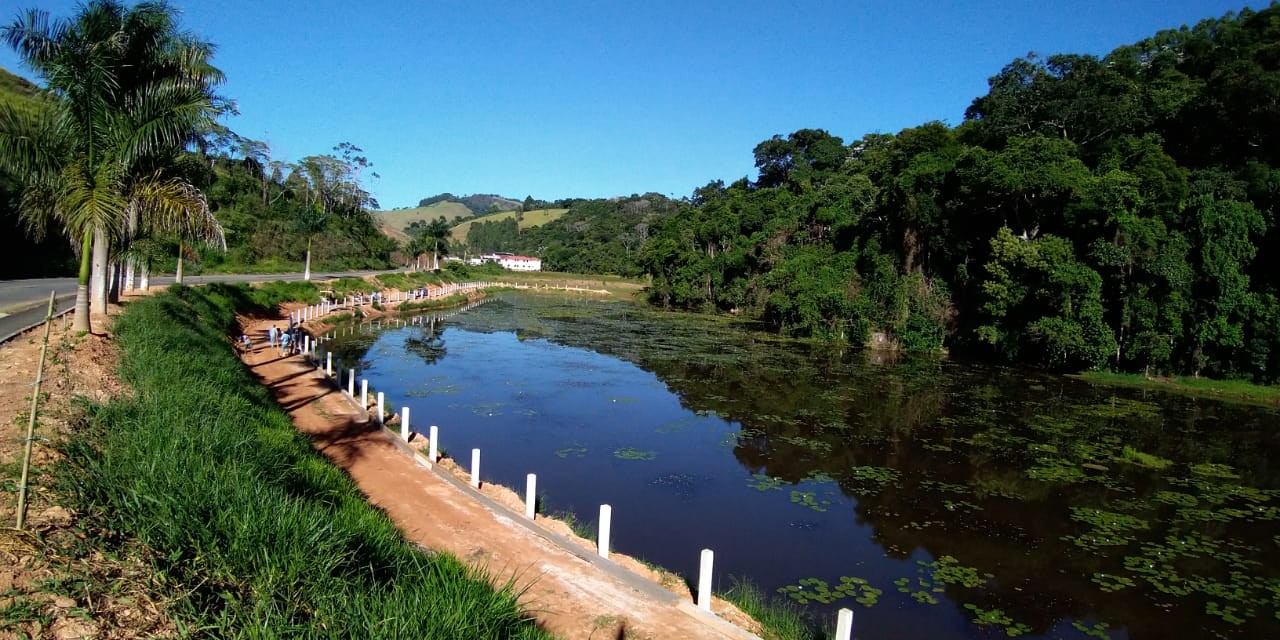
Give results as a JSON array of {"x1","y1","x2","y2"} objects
[{"x1": 60, "y1": 285, "x2": 545, "y2": 639}]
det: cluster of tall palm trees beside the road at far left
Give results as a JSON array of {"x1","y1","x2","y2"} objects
[{"x1": 0, "y1": 0, "x2": 225, "y2": 332}]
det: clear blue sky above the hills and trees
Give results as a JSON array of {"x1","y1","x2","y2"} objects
[{"x1": 0, "y1": 0, "x2": 1266, "y2": 209}]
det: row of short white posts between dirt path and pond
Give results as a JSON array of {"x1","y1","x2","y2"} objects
[{"x1": 290, "y1": 283, "x2": 854, "y2": 640}]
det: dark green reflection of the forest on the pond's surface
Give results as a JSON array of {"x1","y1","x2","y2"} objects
[{"x1": 337, "y1": 300, "x2": 1280, "y2": 637}]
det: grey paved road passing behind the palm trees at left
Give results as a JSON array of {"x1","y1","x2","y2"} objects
[{"x1": 0, "y1": 271, "x2": 392, "y2": 342}]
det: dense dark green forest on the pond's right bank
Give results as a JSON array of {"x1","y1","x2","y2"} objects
[{"x1": 639, "y1": 4, "x2": 1280, "y2": 383}]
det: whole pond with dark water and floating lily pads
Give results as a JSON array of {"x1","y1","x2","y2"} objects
[{"x1": 326, "y1": 296, "x2": 1280, "y2": 639}]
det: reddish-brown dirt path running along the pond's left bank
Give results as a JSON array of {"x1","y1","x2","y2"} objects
[{"x1": 242, "y1": 314, "x2": 754, "y2": 640}]
